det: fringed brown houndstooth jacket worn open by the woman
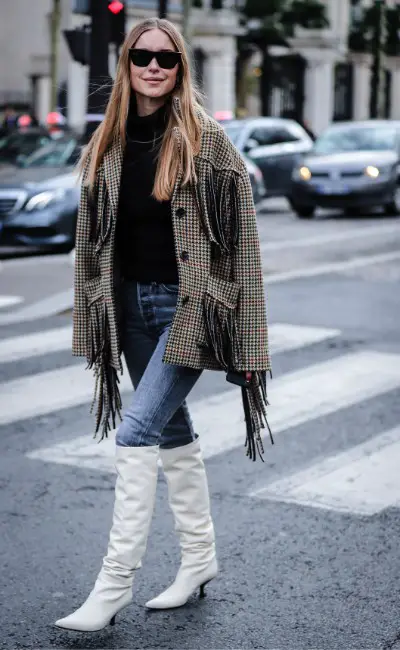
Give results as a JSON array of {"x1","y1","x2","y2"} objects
[{"x1": 72, "y1": 102, "x2": 272, "y2": 460}]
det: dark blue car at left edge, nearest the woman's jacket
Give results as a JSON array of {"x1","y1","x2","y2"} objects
[{"x1": 0, "y1": 138, "x2": 80, "y2": 251}]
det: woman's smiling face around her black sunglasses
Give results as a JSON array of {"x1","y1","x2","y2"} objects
[{"x1": 130, "y1": 29, "x2": 179, "y2": 99}]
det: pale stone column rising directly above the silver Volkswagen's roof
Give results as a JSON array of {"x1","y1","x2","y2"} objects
[{"x1": 302, "y1": 51, "x2": 334, "y2": 135}]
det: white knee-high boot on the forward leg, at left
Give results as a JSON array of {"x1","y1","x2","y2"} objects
[{"x1": 56, "y1": 445, "x2": 159, "y2": 632}]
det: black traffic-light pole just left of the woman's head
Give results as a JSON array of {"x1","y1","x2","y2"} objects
[{"x1": 86, "y1": 0, "x2": 111, "y2": 137}]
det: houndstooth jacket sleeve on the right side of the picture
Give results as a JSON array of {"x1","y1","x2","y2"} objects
[{"x1": 233, "y1": 164, "x2": 271, "y2": 371}]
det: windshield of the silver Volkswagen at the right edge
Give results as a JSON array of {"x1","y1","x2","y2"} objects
[{"x1": 313, "y1": 126, "x2": 396, "y2": 154}]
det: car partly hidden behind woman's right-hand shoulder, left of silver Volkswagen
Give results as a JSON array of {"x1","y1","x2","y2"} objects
[{"x1": 222, "y1": 117, "x2": 313, "y2": 196}]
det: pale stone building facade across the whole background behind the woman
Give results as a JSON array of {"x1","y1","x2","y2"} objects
[{"x1": 0, "y1": 0, "x2": 400, "y2": 134}]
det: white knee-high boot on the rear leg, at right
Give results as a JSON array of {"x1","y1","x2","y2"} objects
[{"x1": 146, "y1": 439, "x2": 218, "y2": 609}]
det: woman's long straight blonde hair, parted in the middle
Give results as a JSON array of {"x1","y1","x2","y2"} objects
[{"x1": 80, "y1": 18, "x2": 202, "y2": 201}]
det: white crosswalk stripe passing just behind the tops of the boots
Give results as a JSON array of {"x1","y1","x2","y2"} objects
[{"x1": 25, "y1": 351, "x2": 400, "y2": 471}]
